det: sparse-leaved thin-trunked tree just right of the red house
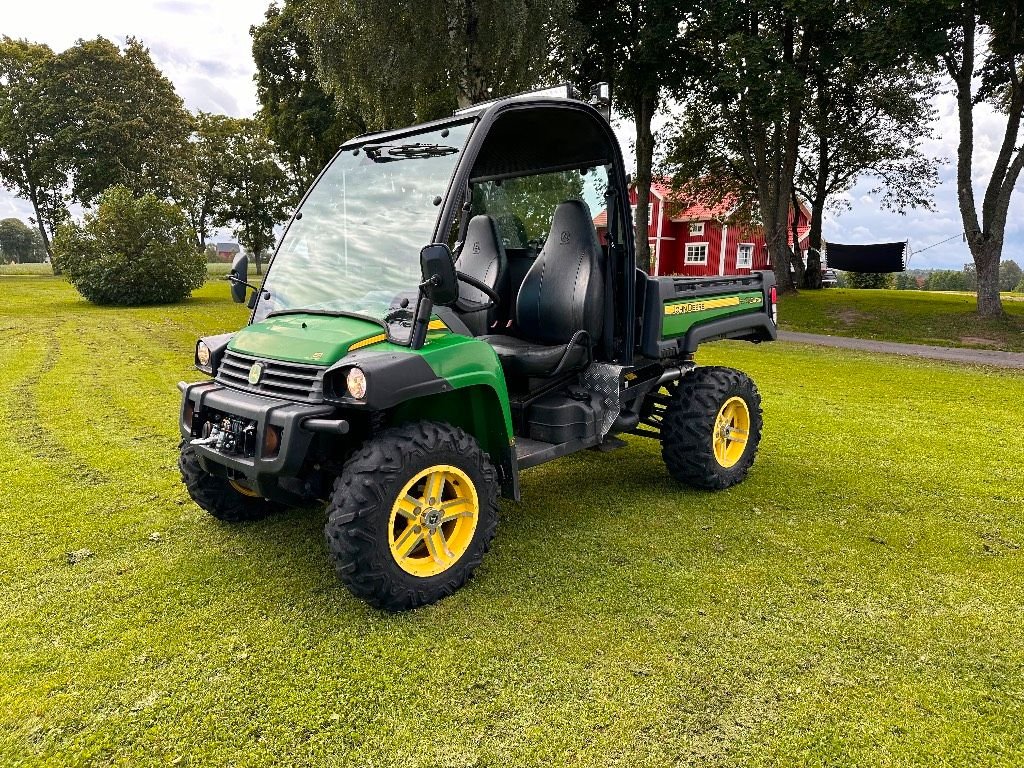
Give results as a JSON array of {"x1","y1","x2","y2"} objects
[{"x1": 796, "y1": 59, "x2": 940, "y2": 288}]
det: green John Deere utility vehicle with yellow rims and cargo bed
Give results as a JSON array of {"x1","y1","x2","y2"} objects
[{"x1": 179, "y1": 83, "x2": 776, "y2": 610}]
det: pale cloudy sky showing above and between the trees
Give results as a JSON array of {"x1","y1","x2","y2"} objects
[{"x1": 0, "y1": 0, "x2": 1024, "y2": 269}]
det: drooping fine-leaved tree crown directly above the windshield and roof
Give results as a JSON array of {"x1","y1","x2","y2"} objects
[{"x1": 303, "y1": 0, "x2": 568, "y2": 130}]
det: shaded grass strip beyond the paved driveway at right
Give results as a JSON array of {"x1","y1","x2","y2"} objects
[{"x1": 779, "y1": 288, "x2": 1024, "y2": 352}]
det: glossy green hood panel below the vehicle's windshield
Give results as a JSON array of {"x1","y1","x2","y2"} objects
[{"x1": 227, "y1": 314, "x2": 384, "y2": 366}]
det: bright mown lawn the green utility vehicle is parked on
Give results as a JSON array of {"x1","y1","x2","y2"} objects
[{"x1": 6, "y1": 278, "x2": 1024, "y2": 768}]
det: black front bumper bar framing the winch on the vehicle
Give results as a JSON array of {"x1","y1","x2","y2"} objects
[{"x1": 178, "y1": 381, "x2": 335, "y2": 497}]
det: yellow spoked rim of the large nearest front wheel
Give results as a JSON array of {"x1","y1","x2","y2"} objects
[{"x1": 388, "y1": 464, "x2": 480, "y2": 578}]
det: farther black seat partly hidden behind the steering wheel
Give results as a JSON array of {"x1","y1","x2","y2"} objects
[{"x1": 456, "y1": 216, "x2": 508, "y2": 336}]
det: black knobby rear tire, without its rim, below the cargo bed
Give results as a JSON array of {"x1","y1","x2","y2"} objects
[{"x1": 662, "y1": 367, "x2": 764, "y2": 490}]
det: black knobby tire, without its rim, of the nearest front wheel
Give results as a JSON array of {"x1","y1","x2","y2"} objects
[{"x1": 324, "y1": 422, "x2": 499, "y2": 611}]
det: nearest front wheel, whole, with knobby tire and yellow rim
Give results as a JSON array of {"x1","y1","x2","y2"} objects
[{"x1": 325, "y1": 422, "x2": 498, "y2": 610}]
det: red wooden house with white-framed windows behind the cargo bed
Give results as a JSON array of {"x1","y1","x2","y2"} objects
[{"x1": 594, "y1": 182, "x2": 811, "y2": 276}]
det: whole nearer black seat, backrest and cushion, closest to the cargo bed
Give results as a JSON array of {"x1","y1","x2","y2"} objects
[{"x1": 483, "y1": 200, "x2": 604, "y2": 377}]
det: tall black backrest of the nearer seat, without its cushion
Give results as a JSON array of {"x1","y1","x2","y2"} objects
[{"x1": 515, "y1": 200, "x2": 604, "y2": 344}]
